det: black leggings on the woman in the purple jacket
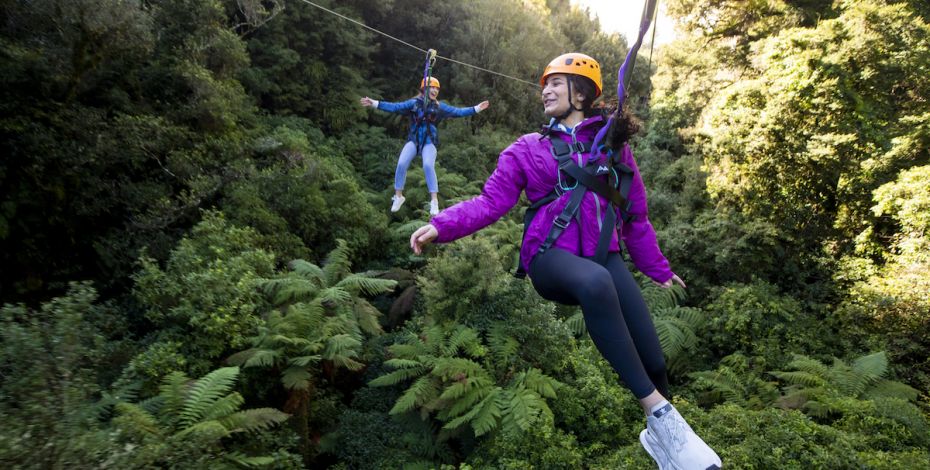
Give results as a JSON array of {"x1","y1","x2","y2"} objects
[{"x1": 529, "y1": 248, "x2": 671, "y2": 399}]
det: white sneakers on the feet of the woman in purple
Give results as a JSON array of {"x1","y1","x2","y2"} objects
[{"x1": 640, "y1": 403, "x2": 723, "y2": 470}]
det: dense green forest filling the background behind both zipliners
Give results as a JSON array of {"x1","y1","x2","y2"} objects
[{"x1": 0, "y1": 0, "x2": 930, "y2": 469}]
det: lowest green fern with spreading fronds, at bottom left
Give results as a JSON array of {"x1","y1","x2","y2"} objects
[{"x1": 108, "y1": 367, "x2": 287, "y2": 468}]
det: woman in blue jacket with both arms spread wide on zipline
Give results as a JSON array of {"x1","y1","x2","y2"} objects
[{"x1": 361, "y1": 77, "x2": 489, "y2": 215}]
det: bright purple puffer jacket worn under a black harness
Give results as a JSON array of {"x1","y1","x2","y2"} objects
[{"x1": 430, "y1": 116, "x2": 673, "y2": 282}]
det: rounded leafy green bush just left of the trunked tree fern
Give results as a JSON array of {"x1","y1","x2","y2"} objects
[{"x1": 133, "y1": 212, "x2": 273, "y2": 377}]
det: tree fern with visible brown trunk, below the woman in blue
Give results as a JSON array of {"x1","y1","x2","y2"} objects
[{"x1": 229, "y1": 240, "x2": 396, "y2": 456}]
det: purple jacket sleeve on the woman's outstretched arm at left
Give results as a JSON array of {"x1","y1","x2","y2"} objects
[{"x1": 430, "y1": 139, "x2": 527, "y2": 243}]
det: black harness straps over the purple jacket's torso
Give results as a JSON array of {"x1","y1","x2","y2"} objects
[{"x1": 514, "y1": 138, "x2": 633, "y2": 278}]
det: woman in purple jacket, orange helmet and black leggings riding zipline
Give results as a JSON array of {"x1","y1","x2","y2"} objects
[{"x1": 410, "y1": 53, "x2": 721, "y2": 469}]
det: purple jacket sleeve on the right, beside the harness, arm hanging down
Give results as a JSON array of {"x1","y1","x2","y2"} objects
[{"x1": 620, "y1": 145, "x2": 674, "y2": 282}]
